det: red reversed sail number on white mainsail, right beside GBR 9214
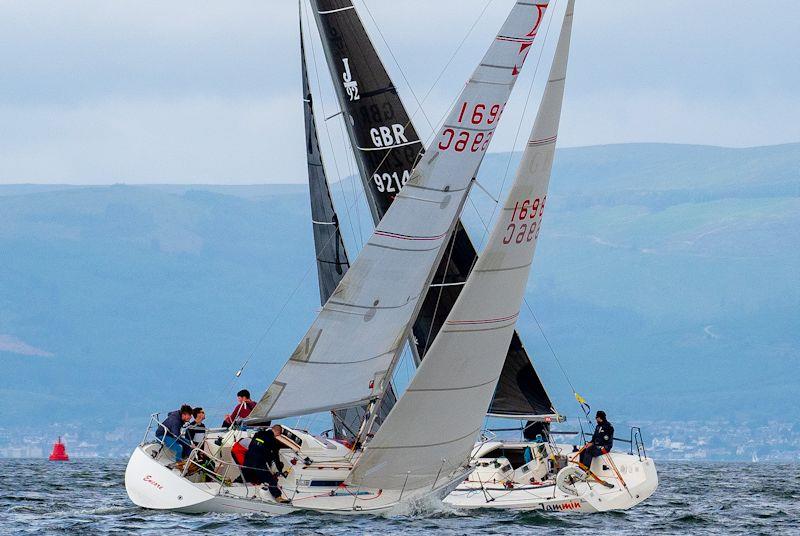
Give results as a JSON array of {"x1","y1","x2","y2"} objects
[{"x1": 438, "y1": 102, "x2": 505, "y2": 153}]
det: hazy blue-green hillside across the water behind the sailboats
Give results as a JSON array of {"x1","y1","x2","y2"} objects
[{"x1": 0, "y1": 144, "x2": 800, "y2": 428}]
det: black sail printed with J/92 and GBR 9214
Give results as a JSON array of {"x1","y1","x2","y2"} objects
[{"x1": 311, "y1": 0, "x2": 556, "y2": 418}]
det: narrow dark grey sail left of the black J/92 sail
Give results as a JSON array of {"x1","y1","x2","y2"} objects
[{"x1": 300, "y1": 14, "x2": 397, "y2": 439}]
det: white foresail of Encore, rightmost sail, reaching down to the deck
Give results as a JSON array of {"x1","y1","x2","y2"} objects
[{"x1": 348, "y1": 0, "x2": 573, "y2": 490}]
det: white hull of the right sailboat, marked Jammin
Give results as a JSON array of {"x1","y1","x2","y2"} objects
[{"x1": 444, "y1": 442, "x2": 658, "y2": 512}]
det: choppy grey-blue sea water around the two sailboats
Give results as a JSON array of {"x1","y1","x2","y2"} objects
[{"x1": 0, "y1": 460, "x2": 800, "y2": 536}]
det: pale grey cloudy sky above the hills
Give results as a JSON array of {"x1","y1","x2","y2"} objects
[{"x1": 0, "y1": 0, "x2": 800, "y2": 184}]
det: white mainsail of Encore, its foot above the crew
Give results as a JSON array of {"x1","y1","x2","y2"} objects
[{"x1": 250, "y1": 0, "x2": 547, "y2": 421}]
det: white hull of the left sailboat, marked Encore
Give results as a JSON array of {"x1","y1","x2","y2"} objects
[{"x1": 125, "y1": 432, "x2": 465, "y2": 515}]
